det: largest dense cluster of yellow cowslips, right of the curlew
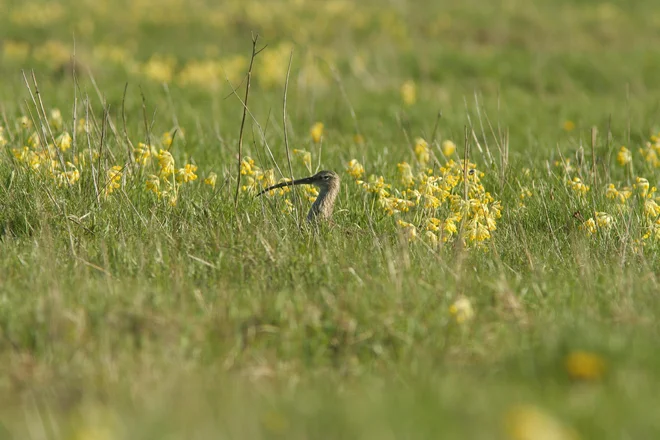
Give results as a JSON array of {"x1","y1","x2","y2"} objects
[{"x1": 346, "y1": 153, "x2": 502, "y2": 245}]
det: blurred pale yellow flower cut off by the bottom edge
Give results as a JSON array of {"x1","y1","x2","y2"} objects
[{"x1": 505, "y1": 406, "x2": 579, "y2": 440}]
